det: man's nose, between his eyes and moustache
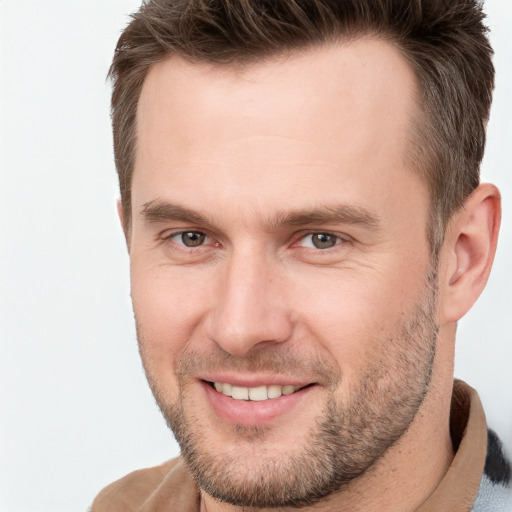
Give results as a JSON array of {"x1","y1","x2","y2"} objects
[{"x1": 210, "y1": 248, "x2": 293, "y2": 355}]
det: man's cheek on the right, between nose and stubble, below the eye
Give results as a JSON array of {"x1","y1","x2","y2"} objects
[{"x1": 296, "y1": 260, "x2": 426, "y2": 376}]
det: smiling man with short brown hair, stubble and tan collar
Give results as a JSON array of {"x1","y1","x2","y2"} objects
[{"x1": 93, "y1": 0, "x2": 512, "y2": 512}]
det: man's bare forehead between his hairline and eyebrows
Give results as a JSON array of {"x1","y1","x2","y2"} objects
[{"x1": 133, "y1": 39, "x2": 424, "y2": 224}]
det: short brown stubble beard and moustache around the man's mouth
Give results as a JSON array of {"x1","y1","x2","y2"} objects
[{"x1": 139, "y1": 270, "x2": 438, "y2": 508}]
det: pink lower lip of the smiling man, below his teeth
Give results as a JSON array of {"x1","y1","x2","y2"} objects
[{"x1": 202, "y1": 382, "x2": 315, "y2": 427}]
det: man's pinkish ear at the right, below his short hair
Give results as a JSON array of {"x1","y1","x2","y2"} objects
[{"x1": 439, "y1": 183, "x2": 501, "y2": 323}]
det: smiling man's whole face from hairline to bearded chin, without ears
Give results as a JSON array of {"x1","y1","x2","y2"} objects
[{"x1": 129, "y1": 40, "x2": 436, "y2": 506}]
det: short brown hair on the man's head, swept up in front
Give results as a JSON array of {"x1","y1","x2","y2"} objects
[{"x1": 109, "y1": 0, "x2": 494, "y2": 253}]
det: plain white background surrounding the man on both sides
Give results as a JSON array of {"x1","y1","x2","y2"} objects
[{"x1": 0, "y1": 0, "x2": 512, "y2": 512}]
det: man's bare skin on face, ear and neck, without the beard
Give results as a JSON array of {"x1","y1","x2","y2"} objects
[{"x1": 124, "y1": 40, "x2": 499, "y2": 512}]
